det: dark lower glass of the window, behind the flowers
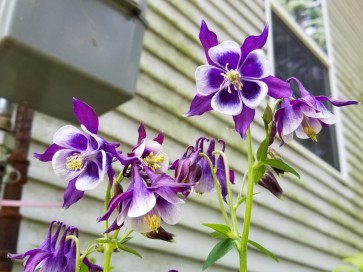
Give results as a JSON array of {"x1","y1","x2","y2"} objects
[{"x1": 272, "y1": 14, "x2": 339, "y2": 170}]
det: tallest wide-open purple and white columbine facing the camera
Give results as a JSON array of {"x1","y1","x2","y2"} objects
[{"x1": 186, "y1": 21, "x2": 291, "y2": 138}]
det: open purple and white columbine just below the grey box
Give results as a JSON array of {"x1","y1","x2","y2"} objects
[{"x1": 34, "y1": 98, "x2": 118, "y2": 208}]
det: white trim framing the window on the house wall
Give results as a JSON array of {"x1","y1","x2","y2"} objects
[{"x1": 265, "y1": 0, "x2": 348, "y2": 179}]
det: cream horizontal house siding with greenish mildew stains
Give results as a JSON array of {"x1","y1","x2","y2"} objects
[{"x1": 14, "y1": 0, "x2": 363, "y2": 272}]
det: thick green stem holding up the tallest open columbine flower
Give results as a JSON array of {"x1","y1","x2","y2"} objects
[{"x1": 239, "y1": 128, "x2": 256, "y2": 272}]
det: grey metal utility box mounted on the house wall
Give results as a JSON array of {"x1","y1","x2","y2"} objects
[{"x1": 0, "y1": 0, "x2": 146, "y2": 121}]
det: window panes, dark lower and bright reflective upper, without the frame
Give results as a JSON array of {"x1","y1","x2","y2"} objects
[{"x1": 272, "y1": 0, "x2": 340, "y2": 170}]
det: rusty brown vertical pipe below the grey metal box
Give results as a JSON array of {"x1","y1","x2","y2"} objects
[{"x1": 0, "y1": 105, "x2": 33, "y2": 272}]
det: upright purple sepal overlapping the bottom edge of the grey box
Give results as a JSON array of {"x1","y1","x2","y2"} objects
[{"x1": 73, "y1": 98, "x2": 98, "y2": 134}]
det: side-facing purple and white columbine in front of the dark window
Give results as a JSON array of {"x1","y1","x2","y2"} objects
[{"x1": 275, "y1": 78, "x2": 358, "y2": 144}]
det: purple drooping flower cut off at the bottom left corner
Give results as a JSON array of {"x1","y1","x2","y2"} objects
[{"x1": 8, "y1": 221, "x2": 103, "y2": 272}]
